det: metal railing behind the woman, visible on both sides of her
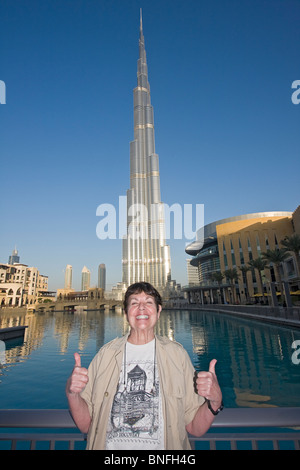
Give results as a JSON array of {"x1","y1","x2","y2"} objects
[{"x1": 0, "y1": 407, "x2": 300, "y2": 450}]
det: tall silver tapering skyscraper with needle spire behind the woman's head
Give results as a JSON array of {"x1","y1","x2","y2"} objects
[{"x1": 122, "y1": 14, "x2": 171, "y2": 289}]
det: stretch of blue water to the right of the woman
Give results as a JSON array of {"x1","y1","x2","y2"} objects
[{"x1": 160, "y1": 311, "x2": 300, "y2": 407}]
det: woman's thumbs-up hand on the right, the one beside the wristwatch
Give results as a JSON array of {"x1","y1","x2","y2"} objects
[{"x1": 195, "y1": 359, "x2": 222, "y2": 408}]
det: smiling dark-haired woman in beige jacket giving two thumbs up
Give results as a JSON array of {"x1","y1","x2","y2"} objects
[{"x1": 66, "y1": 282, "x2": 223, "y2": 450}]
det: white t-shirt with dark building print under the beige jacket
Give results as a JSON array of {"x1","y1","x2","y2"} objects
[{"x1": 106, "y1": 339, "x2": 164, "y2": 450}]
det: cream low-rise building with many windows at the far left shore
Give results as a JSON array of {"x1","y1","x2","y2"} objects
[{"x1": 0, "y1": 263, "x2": 49, "y2": 307}]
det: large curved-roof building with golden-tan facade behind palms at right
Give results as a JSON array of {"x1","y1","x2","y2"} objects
[{"x1": 185, "y1": 206, "x2": 300, "y2": 303}]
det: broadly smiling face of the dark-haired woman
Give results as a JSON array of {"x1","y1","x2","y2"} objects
[{"x1": 126, "y1": 292, "x2": 161, "y2": 336}]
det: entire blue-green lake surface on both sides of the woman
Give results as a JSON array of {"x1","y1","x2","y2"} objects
[{"x1": 0, "y1": 309, "x2": 300, "y2": 409}]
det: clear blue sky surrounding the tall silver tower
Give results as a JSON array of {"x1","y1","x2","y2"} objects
[{"x1": 0, "y1": 0, "x2": 300, "y2": 290}]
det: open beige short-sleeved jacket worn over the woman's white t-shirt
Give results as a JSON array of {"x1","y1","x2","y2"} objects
[{"x1": 81, "y1": 335, "x2": 205, "y2": 450}]
